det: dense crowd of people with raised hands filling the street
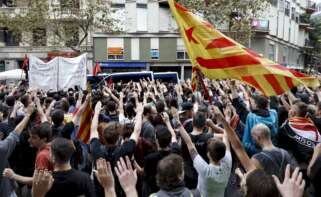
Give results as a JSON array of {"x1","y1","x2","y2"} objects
[{"x1": 0, "y1": 79, "x2": 321, "y2": 197}]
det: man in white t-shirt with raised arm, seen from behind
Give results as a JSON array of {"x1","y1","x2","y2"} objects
[{"x1": 175, "y1": 111, "x2": 232, "y2": 197}]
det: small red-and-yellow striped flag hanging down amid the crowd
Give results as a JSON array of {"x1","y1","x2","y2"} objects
[{"x1": 77, "y1": 85, "x2": 93, "y2": 144}]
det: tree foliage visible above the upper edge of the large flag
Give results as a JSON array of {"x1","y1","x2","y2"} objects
[{"x1": 179, "y1": 0, "x2": 270, "y2": 43}]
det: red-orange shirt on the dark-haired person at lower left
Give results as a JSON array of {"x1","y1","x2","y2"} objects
[{"x1": 35, "y1": 144, "x2": 53, "y2": 171}]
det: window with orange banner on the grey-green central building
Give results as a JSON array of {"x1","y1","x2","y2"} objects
[{"x1": 107, "y1": 38, "x2": 124, "y2": 60}]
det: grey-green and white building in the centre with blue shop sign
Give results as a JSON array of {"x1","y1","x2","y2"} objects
[{"x1": 93, "y1": 0, "x2": 192, "y2": 78}]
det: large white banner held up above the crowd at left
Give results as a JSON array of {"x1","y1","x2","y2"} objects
[{"x1": 28, "y1": 54, "x2": 87, "y2": 91}]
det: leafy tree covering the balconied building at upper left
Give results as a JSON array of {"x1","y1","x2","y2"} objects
[{"x1": 0, "y1": 0, "x2": 120, "y2": 52}]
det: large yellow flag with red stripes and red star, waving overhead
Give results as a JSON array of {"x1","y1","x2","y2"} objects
[{"x1": 168, "y1": 0, "x2": 319, "y2": 96}]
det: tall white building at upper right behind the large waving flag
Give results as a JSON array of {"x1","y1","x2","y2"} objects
[{"x1": 250, "y1": 0, "x2": 316, "y2": 69}]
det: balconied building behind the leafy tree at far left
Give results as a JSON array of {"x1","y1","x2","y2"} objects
[{"x1": 0, "y1": 0, "x2": 93, "y2": 71}]
